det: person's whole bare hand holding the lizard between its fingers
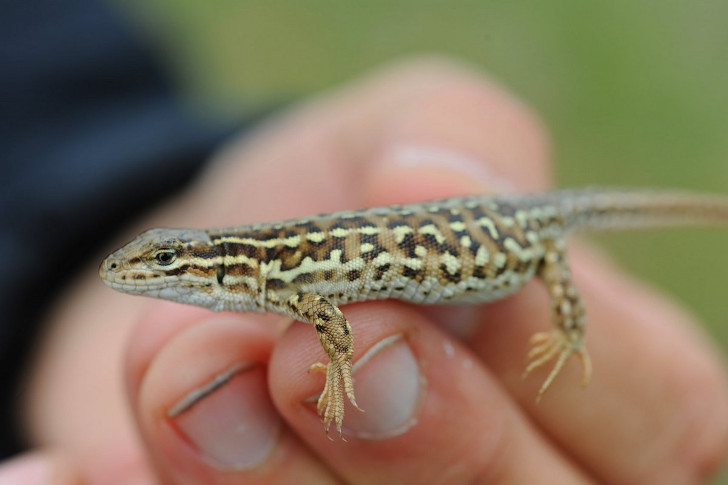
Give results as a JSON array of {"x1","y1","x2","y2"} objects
[{"x1": 5, "y1": 60, "x2": 728, "y2": 484}]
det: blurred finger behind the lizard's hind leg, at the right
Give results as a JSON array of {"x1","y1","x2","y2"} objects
[{"x1": 470, "y1": 244, "x2": 728, "y2": 483}]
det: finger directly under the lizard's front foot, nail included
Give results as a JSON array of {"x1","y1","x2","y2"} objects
[{"x1": 270, "y1": 302, "x2": 588, "y2": 484}]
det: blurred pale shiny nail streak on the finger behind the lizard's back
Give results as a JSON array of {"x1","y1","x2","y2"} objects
[{"x1": 385, "y1": 144, "x2": 516, "y2": 193}]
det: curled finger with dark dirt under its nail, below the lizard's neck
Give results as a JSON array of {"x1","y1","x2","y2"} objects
[{"x1": 127, "y1": 305, "x2": 333, "y2": 483}]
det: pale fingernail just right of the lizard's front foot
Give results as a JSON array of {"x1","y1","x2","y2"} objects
[{"x1": 344, "y1": 334, "x2": 425, "y2": 439}]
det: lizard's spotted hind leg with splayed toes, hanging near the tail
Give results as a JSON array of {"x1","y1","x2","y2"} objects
[{"x1": 523, "y1": 236, "x2": 591, "y2": 400}]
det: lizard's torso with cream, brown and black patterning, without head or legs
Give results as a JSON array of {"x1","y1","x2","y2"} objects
[{"x1": 213, "y1": 198, "x2": 562, "y2": 313}]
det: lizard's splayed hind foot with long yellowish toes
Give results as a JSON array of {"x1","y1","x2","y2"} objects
[{"x1": 523, "y1": 329, "x2": 591, "y2": 402}]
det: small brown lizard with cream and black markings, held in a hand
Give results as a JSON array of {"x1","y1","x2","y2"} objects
[{"x1": 99, "y1": 188, "x2": 728, "y2": 434}]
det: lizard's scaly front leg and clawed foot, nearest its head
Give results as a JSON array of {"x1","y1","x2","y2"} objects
[{"x1": 287, "y1": 293, "x2": 361, "y2": 435}]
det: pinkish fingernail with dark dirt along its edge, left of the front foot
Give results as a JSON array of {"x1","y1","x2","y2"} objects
[{"x1": 168, "y1": 364, "x2": 280, "y2": 470}]
